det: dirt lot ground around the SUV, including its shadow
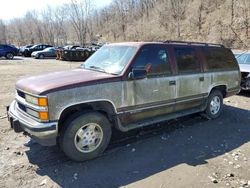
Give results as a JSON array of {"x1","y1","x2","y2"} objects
[{"x1": 0, "y1": 58, "x2": 250, "y2": 188}]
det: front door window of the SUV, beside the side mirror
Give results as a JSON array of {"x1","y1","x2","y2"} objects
[{"x1": 133, "y1": 45, "x2": 171, "y2": 76}]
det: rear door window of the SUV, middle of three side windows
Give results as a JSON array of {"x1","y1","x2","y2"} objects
[{"x1": 174, "y1": 47, "x2": 200, "y2": 73}]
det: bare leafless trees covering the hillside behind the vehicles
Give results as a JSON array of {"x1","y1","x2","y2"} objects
[{"x1": 0, "y1": 0, "x2": 250, "y2": 48}]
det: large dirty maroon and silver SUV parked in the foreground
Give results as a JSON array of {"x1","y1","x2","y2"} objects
[{"x1": 7, "y1": 41, "x2": 240, "y2": 161}]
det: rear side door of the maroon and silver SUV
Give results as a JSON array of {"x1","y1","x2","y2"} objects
[{"x1": 173, "y1": 46, "x2": 205, "y2": 111}]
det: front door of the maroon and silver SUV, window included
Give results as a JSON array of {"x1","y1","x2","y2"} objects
[{"x1": 120, "y1": 44, "x2": 176, "y2": 123}]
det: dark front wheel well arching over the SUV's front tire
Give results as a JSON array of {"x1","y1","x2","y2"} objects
[{"x1": 58, "y1": 101, "x2": 116, "y2": 132}]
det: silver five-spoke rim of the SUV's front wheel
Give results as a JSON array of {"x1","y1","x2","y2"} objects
[{"x1": 75, "y1": 123, "x2": 103, "y2": 153}]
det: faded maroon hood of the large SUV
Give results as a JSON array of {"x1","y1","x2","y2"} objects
[{"x1": 16, "y1": 68, "x2": 120, "y2": 95}]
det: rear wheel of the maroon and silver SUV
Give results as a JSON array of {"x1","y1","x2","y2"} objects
[{"x1": 205, "y1": 90, "x2": 223, "y2": 119}]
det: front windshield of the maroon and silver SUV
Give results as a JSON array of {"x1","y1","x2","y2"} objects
[{"x1": 81, "y1": 45, "x2": 136, "y2": 74}]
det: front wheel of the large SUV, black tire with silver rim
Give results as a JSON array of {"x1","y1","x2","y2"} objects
[{"x1": 59, "y1": 112, "x2": 112, "y2": 161}]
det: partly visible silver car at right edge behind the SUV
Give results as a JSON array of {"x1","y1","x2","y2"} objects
[{"x1": 235, "y1": 51, "x2": 250, "y2": 90}]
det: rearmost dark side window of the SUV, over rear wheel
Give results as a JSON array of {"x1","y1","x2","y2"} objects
[{"x1": 203, "y1": 48, "x2": 237, "y2": 71}]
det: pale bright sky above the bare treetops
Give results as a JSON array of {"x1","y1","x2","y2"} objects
[{"x1": 0, "y1": 0, "x2": 112, "y2": 20}]
